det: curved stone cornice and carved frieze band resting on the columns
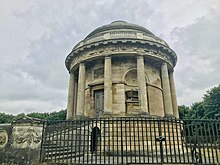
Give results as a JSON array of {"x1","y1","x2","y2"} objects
[{"x1": 65, "y1": 39, "x2": 177, "y2": 70}]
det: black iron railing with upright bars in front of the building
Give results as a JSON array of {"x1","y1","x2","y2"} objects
[{"x1": 41, "y1": 117, "x2": 220, "y2": 165}]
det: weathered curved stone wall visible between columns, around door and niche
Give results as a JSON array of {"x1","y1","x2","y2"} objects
[{"x1": 84, "y1": 55, "x2": 164, "y2": 117}]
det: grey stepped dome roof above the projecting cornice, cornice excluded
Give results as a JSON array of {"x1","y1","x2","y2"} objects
[{"x1": 73, "y1": 21, "x2": 169, "y2": 51}]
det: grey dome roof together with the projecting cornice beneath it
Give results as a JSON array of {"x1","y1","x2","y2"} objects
[{"x1": 65, "y1": 21, "x2": 177, "y2": 70}]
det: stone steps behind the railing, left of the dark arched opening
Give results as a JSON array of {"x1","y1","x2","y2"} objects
[{"x1": 41, "y1": 124, "x2": 89, "y2": 162}]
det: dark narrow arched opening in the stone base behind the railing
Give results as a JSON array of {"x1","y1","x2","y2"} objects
[{"x1": 90, "y1": 126, "x2": 101, "y2": 153}]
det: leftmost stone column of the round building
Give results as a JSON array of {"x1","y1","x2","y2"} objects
[{"x1": 66, "y1": 72, "x2": 75, "y2": 120}]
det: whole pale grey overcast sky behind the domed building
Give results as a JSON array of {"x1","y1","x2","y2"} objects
[{"x1": 0, "y1": 0, "x2": 220, "y2": 114}]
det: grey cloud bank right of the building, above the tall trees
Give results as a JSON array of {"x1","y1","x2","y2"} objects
[{"x1": 172, "y1": 11, "x2": 220, "y2": 104}]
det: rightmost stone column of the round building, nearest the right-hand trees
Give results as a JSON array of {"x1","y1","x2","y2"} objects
[{"x1": 170, "y1": 72, "x2": 179, "y2": 118}]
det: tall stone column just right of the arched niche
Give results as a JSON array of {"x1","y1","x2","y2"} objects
[{"x1": 137, "y1": 56, "x2": 149, "y2": 114}]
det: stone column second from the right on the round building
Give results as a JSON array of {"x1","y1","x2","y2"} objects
[{"x1": 161, "y1": 63, "x2": 173, "y2": 117}]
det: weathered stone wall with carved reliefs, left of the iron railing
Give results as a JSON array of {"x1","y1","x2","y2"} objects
[{"x1": 0, "y1": 118, "x2": 43, "y2": 165}]
